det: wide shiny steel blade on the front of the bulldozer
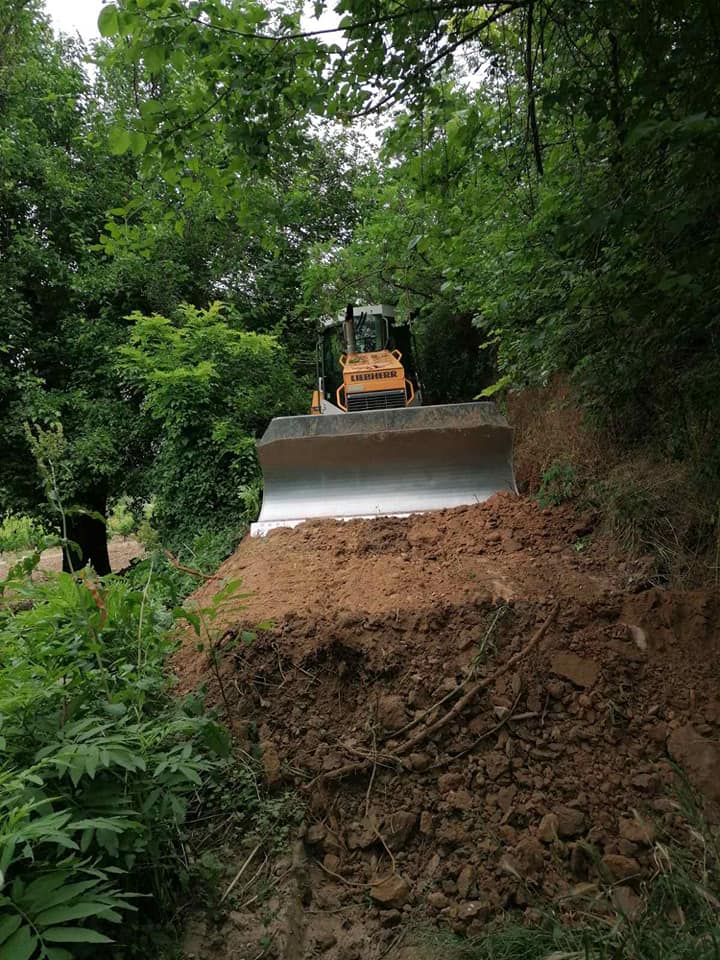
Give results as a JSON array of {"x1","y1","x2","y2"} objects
[{"x1": 251, "y1": 402, "x2": 517, "y2": 536}]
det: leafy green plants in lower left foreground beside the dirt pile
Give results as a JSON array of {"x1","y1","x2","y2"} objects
[{"x1": 0, "y1": 571, "x2": 228, "y2": 960}]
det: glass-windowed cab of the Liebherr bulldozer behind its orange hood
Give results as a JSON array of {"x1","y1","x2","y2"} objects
[{"x1": 317, "y1": 304, "x2": 419, "y2": 404}]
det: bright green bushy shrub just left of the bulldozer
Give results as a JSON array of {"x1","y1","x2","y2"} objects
[{"x1": 120, "y1": 303, "x2": 305, "y2": 555}]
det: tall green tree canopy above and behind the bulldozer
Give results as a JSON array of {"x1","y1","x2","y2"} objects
[{"x1": 0, "y1": 0, "x2": 720, "y2": 568}]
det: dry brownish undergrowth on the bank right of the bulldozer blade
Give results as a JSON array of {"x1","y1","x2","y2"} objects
[{"x1": 509, "y1": 380, "x2": 720, "y2": 588}]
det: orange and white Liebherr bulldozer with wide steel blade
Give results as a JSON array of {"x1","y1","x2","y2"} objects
[{"x1": 250, "y1": 304, "x2": 517, "y2": 536}]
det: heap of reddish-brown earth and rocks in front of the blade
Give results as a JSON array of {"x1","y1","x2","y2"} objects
[{"x1": 176, "y1": 495, "x2": 720, "y2": 960}]
